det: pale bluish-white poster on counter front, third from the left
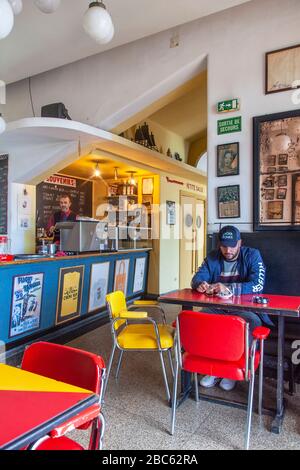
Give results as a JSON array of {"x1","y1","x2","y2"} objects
[{"x1": 88, "y1": 262, "x2": 110, "y2": 312}]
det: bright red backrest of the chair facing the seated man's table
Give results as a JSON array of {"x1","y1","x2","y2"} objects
[{"x1": 179, "y1": 311, "x2": 247, "y2": 361}]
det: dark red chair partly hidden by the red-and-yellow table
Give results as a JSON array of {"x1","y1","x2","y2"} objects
[{"x1": 21, "y1": 342, "x2": 105, "y2": 450}]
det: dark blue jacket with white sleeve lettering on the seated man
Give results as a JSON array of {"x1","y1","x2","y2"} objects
[{"x1": 191, "y1": 246, "x2": 273, "y2": 325}]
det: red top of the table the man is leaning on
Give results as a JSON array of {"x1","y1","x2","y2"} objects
[{"x1": 158, "y1": 289, "x2": 300, "y2": 317}]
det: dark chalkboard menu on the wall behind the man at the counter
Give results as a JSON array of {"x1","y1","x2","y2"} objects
[{"x1": 36, "y1": 175, "x2": 93, "y2": 228}]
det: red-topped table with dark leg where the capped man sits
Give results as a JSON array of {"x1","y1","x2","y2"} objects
[{"x1": 159, "y1": 289, "x2": 300, "y2": 434}]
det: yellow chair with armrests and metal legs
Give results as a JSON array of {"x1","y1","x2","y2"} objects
[{"x1": 103, "y1": 291, "x2": 174, "y2": 401}]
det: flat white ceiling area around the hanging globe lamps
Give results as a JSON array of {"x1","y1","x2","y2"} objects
[{"x1": 0, "y1": 0, "x2": 249, "y2": 83}]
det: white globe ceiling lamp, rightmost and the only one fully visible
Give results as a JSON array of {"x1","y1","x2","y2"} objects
[{"x1": 83, "y1": 0, "x2": 115, "y2": 44}]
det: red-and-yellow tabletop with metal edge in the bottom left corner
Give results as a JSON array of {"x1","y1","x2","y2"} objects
[{"x1": 0, "y1": 364, "x2": 99, "y2": 450}]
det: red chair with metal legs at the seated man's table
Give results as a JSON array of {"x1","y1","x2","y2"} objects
[{"x1": 171, "y1": 311, "x2": 270, "y2": 450}]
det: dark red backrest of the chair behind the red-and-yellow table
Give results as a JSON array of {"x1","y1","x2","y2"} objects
[{"x1": 21, "y1": 342, "x2": 105, "y2": 395}]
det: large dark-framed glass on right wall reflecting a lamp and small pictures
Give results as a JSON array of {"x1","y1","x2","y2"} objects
[{"x1": 253, "y1": 109, "x2": 300, "y2": 230}]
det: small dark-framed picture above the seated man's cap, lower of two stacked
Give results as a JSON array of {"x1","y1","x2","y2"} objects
[{"x1": 217, "y1": 185, "x2": 241, "y2": 219}]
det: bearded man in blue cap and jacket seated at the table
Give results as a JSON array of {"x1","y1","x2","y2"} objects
[{"x1": 191, "y1": 225, "x2": 272, "y2": 391}]
